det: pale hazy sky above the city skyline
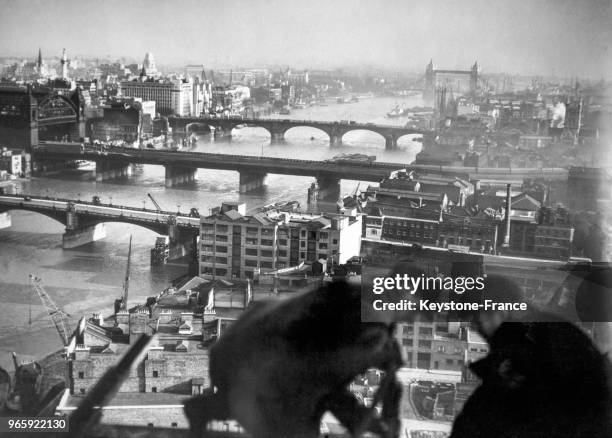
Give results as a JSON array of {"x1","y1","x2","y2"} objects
[{"x1": 0, "y1": 0, "x2": 612, "y2": 78}]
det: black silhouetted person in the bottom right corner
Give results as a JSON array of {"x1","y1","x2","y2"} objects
[{"x1": 451, "y1": 276, "x2": 612, "y2": 438}]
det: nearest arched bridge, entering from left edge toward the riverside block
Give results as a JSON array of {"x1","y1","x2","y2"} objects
[{"x1": 0, "y1": 195, "x2": 200, "y2": 259}]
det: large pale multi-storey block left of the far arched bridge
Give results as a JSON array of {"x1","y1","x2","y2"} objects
[{"x1": 120, "y1": 77, "x2": 193, "y2": 116}]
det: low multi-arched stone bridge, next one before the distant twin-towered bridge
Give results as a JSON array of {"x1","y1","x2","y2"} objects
[{"x1": 168, "y1": 117, "x2": 433, "y2": 150}]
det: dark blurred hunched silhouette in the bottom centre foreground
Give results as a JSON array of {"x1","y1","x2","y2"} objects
[{"x1": 185, "y1": 282, "x2": 401, "y2": 438}]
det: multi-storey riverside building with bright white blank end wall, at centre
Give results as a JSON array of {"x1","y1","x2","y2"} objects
[{"x1": 200, "y1": 203, "x2": 361, "y2": 279}]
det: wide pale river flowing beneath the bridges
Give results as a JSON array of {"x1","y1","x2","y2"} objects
[{"x1": 0, "y1": 96, "x2": 423, "y2": 370}]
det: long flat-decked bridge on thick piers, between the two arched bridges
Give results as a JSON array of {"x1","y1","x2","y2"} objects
[{"x1": 33, "y1": 143, "x2": 568, "y2": 195}]
